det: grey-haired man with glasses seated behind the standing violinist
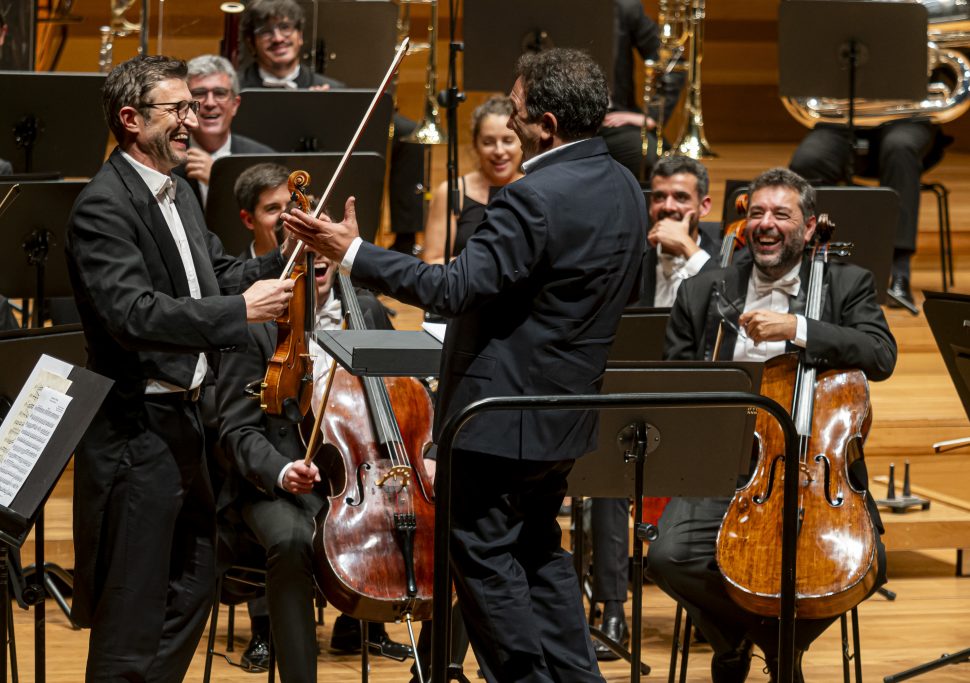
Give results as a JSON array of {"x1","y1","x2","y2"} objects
[{"x1": 175, "y1": 55, "x2": 276, "y2": 208}]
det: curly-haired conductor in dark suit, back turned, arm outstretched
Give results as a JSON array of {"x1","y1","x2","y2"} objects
[{"x1": 284, "y1": 49, "x2": 646, "y2": 683}]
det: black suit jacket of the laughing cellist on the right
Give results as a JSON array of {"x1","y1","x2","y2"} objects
[{"x1": 665, "y1": 258, "x2": 896, "y2": 380}]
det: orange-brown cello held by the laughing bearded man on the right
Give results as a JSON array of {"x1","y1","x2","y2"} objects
[{"x1": 715, "y1": 215, "x2": 879, "y2": 619}]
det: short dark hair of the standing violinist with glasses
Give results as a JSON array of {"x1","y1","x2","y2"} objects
[{"x1": 101, "y1": 55, "x2": 188, "y2": 144}]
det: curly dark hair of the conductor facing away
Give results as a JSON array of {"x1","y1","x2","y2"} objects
[{"x1": 515, "y1": 48, "x2": 609, "y2": 142}]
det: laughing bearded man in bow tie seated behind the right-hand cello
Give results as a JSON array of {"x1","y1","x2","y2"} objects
[{"x1": 648, "y1": 169, "x2": 896, "y2": 683}]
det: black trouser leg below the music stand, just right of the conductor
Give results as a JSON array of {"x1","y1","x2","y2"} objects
[{"x1": 590, "y1": 498, "x2": 630, "y2": 602}]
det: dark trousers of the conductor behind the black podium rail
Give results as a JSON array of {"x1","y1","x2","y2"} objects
[{"x1": 451, "y1": 450, "x2": 603, "y2": 683}]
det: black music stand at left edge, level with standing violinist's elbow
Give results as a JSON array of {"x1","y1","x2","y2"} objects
[{"x1": 0, "y1": 180, "x2": 86, "y2": 327}]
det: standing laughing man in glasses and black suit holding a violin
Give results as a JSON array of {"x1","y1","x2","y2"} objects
[{"x1": 67, "y1": 56, "x2": 292, "y2": 681}]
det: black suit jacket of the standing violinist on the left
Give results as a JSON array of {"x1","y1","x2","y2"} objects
[{"x1": 67, "y1": 149, "x2": 283, "y2": 396}]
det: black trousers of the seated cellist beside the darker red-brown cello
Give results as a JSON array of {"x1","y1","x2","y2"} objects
[{"x1": 241, "y1": 492, "x2": 324, "y2": 683}]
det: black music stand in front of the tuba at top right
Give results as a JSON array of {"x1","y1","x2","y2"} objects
[{"x1": 778, "y1": 0, "x2": 927, "y2": 191}]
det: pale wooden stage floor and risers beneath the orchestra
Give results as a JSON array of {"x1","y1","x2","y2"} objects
[{"x1": 15, "y1": 145, "x2": 970, "y2": 683}]
